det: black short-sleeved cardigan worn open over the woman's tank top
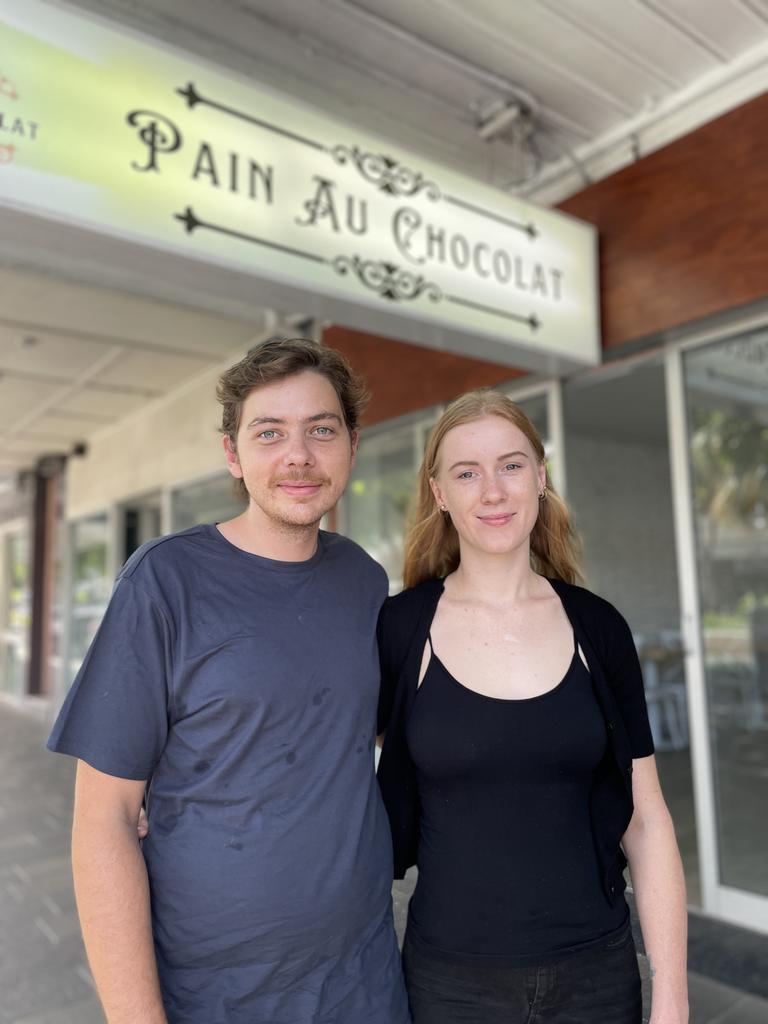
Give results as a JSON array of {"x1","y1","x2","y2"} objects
[{"x1": 378, "y1": 580, "x2": 653, "y2": 902}]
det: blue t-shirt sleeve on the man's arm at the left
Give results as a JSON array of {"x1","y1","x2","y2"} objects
[{"x1": 47, "y1": 578, "x2": 172, "y2": 780}]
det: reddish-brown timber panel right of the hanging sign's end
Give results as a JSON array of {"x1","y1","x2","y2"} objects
[{"x1": 560, "y1": 93, "x2": 768, "y2": 348}]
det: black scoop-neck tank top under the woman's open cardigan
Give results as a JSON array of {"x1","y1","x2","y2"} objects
[{"x1": 408, "y1": 626, "x2": 628, "y2": 966}]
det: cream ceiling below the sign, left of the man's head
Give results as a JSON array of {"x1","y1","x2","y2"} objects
[{"x1": 0, "y1": 268, "x2": 263, "y2": 466}]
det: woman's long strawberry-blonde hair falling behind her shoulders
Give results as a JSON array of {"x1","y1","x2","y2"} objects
[{"x1": 402, "y1": 388, "x2": 581, "y2": 587}]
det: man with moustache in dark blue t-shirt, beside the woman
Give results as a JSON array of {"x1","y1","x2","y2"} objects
[{"x1": 48, "y1": 340, "x2": 410, "y2": 1024}]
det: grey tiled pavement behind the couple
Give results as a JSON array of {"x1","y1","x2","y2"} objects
[{"x1": 0, "y1": 700, "x2": 768, "y2": 1024}]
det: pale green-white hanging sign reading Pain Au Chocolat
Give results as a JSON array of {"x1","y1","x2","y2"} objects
[{"x1": 0, "y1": 0, "x2": 599, "y2": 366}]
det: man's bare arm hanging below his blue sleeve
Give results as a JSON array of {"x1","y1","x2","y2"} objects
[{"x1": 72, "y1": 761, "x2": 167, "y2": 1024}]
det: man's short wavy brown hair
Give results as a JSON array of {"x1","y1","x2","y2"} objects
[{"x1": 216, "y1": 338, "x2": 370, "y2": 500}]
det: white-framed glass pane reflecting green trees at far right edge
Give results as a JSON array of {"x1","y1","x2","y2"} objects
[{"x1": 683, "y1": 331, "x2": 768, "y2": 896}]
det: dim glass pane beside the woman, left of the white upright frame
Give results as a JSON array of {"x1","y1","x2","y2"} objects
[{"x1": 563, "y1": 354, "x2": 702, "y2": 905}]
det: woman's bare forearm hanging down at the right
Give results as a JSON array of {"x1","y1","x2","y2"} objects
[{"x1": 622, "y1": 756, "x2": 688, "y2": 1024}]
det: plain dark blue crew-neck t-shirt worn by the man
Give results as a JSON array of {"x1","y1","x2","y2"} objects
[{"x1": 48, "y1": 525, "x2": 409, "y2": 1024}]
